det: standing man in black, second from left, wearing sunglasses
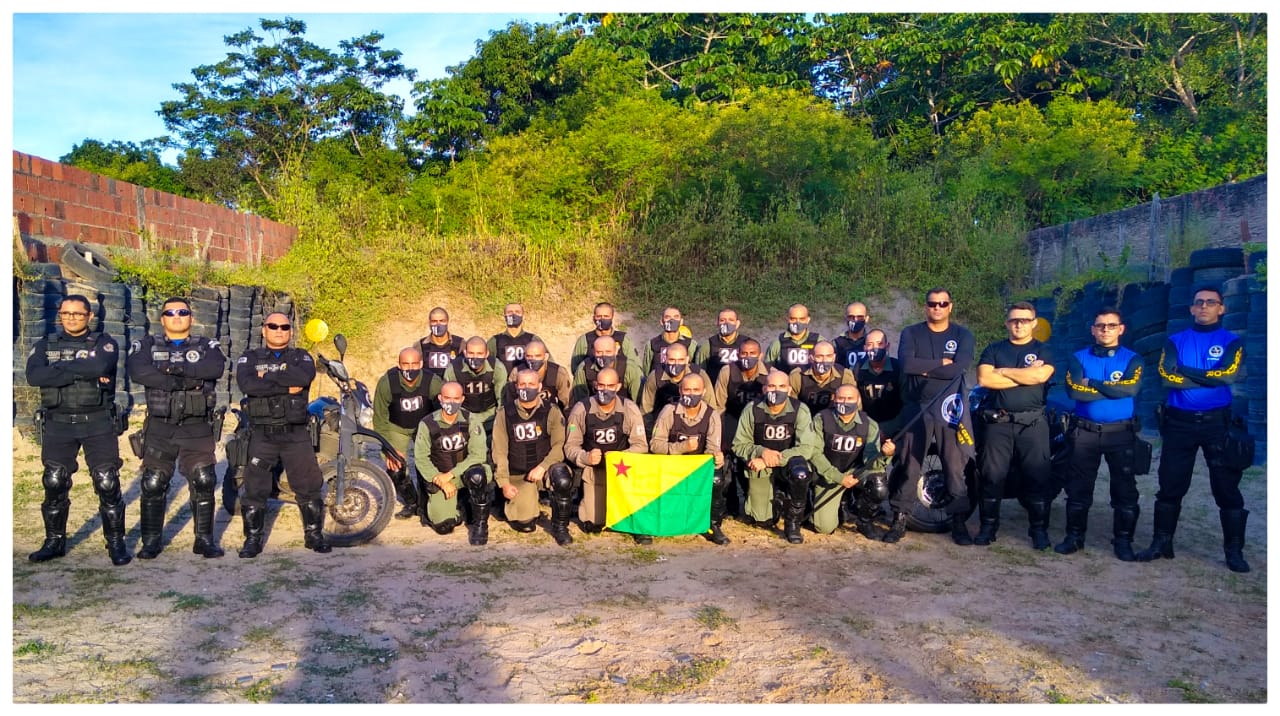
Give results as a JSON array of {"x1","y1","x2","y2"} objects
[{"x1": 125, "y1": 297, "x2": 227, "y2": 560}]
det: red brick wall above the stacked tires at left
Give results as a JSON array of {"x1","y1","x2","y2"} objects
[{"x1": 13, "y1": 151, "x2": 298, "y2": 265}]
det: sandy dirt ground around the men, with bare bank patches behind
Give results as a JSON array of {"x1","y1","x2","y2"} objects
[{"x1": 13, "y1": 293, "x2": 1267, "y2": 704}]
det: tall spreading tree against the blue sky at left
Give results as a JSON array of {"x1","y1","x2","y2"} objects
[{"x1": 159, "y1": 18, "x2": 416, "y2": 210}]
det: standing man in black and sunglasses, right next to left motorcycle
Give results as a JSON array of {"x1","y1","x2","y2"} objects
[{"x1": 236, "y1": 313, "x2": 333, "y2": 558}]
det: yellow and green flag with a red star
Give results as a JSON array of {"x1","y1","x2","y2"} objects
[{"x1": 604, "y1": 452, "x2": 716, "y2": 537}]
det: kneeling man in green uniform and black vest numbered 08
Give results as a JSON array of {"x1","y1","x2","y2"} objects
[{"x1": 733, "y1": 370, "x2": 822, "y2": 544}]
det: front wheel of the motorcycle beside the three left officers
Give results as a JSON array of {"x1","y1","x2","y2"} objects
[{"x1": 320, "y1": 459, "x2": 396, "y2": 547}]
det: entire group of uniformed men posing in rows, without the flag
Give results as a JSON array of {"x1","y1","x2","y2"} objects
[{"x1": 27, "y1": 288, "x2": 1249, "y2": 571}]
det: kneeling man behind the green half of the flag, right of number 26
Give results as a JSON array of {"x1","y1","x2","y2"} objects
[{"x1": 649, "y1": 373, "x2": 731, "y2": 546}]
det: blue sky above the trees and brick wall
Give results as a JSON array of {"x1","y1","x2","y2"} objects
[{"x1": 10, "y1": 10, "x2": 559, "y2": 161}]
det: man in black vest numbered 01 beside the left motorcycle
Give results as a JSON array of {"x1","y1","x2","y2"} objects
[{"x1": 374, "y1": 346, "x2": 440, "y2": 524}]
